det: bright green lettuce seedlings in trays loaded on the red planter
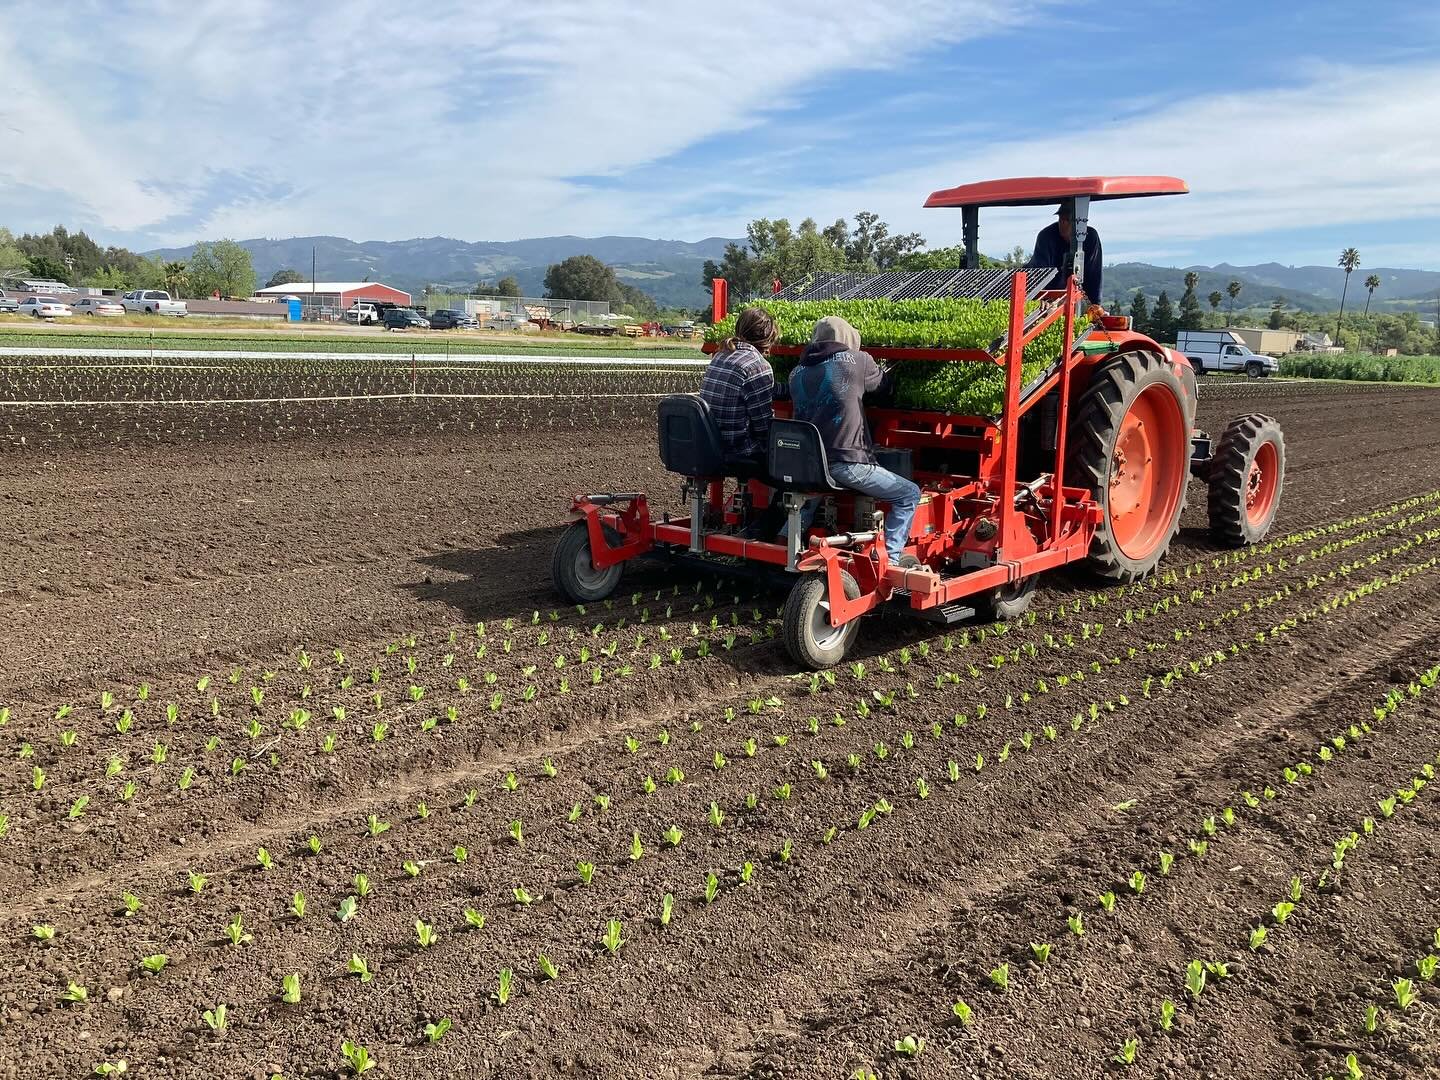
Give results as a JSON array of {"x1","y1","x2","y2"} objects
[{"x1": 707, "y1": 298, "x2": 1082, "y2": 416}]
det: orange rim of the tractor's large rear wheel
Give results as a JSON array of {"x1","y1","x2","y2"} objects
[{"x1": 1109, "y1": 383, "x2": 1189, "y2": 562}]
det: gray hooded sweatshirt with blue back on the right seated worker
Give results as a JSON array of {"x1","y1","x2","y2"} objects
[{"x1": 791, "y1": 317, "x2": 881, "y2": 465}]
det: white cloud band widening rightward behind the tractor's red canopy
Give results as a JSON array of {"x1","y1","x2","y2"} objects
[{"x1": 765, "y1": 59, "x2": 1440, "y2": 262}]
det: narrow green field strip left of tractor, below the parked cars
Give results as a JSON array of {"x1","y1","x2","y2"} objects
[{"x1": 0, "y1": 317, "x2": 700, "y2": 357}]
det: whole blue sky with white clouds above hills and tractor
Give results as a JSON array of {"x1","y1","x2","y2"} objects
[{"x1": 0, "y1": 0, "x2": 1440, "y2": 268}]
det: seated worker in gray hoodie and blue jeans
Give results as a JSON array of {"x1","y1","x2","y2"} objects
[{"x1": 791, "y1": 315, "x2": 920, "y2": 567}]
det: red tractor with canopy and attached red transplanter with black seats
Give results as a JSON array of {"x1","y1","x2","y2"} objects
[{"x1": 553, "y1": 177, "x2": 1284, "y2": 668}]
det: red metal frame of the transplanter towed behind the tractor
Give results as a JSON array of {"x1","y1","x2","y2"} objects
[{"x1": 572, "y1": 264, "x2": 1117, "y2": 626}]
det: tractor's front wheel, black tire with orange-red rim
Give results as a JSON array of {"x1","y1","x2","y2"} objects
[{"x1": 1210, "y1": 413, "x2": 1284, "y2": 547}]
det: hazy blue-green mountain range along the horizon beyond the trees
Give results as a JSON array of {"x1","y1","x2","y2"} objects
[{"x1": 137, "y1": 236, "x2": 1440, "y2": 312}]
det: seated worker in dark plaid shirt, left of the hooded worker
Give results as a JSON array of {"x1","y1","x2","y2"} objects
[{"x1": 700, "y1": 308, "x2": 785, "y2": 540}]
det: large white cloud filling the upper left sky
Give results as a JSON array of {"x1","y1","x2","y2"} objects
[{"x1": 0, "y1": 0, "x2": 1036, "y2": 243}]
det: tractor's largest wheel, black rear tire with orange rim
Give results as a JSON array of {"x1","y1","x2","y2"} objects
[{"x1": 1066, "y1": 351, "x2": 1191, "y2": 582}]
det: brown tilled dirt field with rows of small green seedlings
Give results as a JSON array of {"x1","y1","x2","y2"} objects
[{"x1": 0, "y1": 376, "x2": 1440, "y2": 1080}]
